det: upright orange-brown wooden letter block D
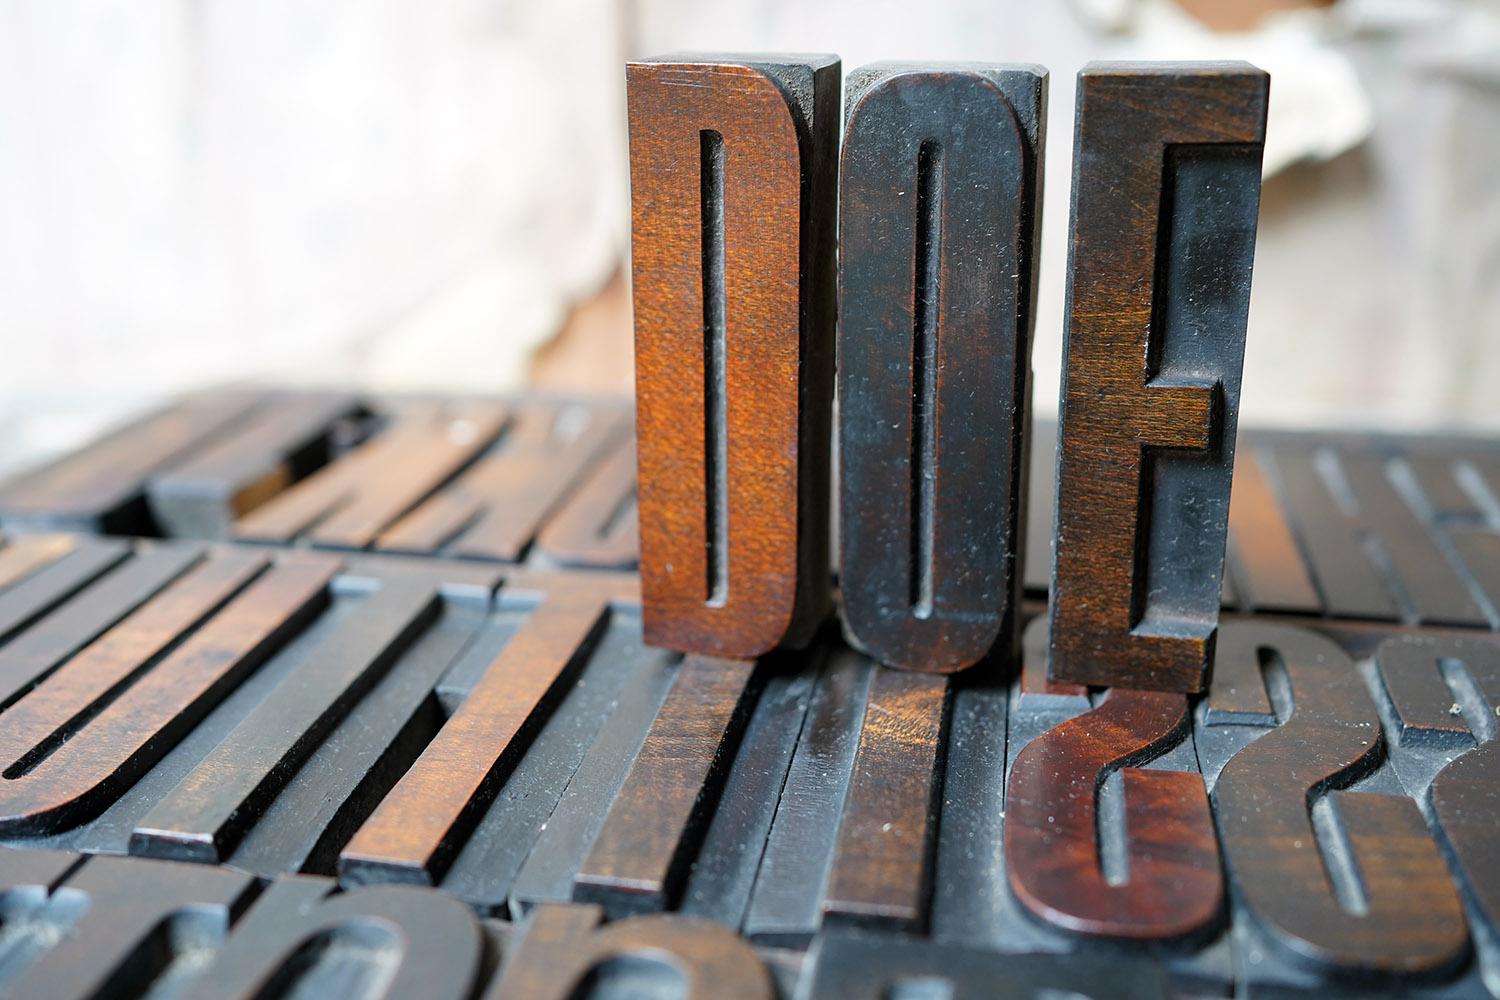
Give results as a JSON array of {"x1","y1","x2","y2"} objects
[{"x1": 626, "y1": 55, "x2": 839, "y2": 658}]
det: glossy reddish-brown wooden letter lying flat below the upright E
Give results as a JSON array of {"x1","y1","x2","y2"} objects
[{"x1": 1005, "y1": 688, "x2": 1224, "y2": 940}]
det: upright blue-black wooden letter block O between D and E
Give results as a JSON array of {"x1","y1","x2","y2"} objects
[{"x1": 839, "y1": 63, "x2": 1047, "y2": 673}]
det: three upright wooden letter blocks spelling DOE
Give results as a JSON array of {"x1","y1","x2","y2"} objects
[{"x1": 627, "y1": 55, "x2": 1268, "y2": 693}]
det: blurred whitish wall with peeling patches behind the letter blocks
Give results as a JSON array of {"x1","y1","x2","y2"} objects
[{"x1": 0, "y1": 0, "x2": 1500, "y2": 468}]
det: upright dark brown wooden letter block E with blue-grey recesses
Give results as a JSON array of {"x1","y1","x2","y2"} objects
[{"x1": 1049, "y1": 63, "x2": 1269, "y2": 691}]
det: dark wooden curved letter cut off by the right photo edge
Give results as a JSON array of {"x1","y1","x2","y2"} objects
[{"x1": 1376, "y1": 636, "x2": 1500, "y2": 928}]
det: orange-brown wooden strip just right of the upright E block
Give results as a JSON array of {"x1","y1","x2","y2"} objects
[{"x1": 1229, "y1": 441, "x2": 1322, "y2": 612}]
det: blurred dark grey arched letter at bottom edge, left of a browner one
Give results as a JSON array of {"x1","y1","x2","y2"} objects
[{"x1": 186, "y1": 862, "x2": 485, "y2": 1000}]
